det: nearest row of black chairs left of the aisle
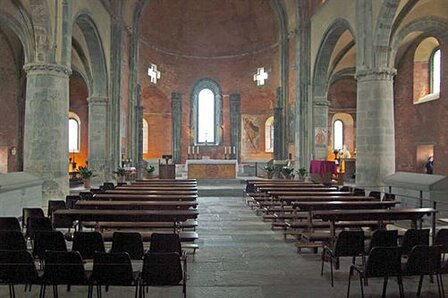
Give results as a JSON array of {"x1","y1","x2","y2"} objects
[{"x1": 0, "y1": 250, "x2": 187, "y2": 298}]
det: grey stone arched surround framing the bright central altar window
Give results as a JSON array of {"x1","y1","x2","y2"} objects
[{"x1": 190, "y1": 78, "x2": 223, "y2": 145}]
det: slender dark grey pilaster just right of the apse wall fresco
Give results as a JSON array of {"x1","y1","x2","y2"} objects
[{"x1": 274, "y1": 87, "x2": 287, "y2": 160}]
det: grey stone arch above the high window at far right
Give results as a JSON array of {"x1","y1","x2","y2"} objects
[{"x1": 388, "y1": 17, "x2": 448, "y2": 67}]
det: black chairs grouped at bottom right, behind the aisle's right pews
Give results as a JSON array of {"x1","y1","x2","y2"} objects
[{"x1": 321, "y1": 229, "x2": 448, "y2": 294}]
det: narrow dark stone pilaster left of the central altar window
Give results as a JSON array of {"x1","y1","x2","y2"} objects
[{"x1": 171, "y1": 92, "x2": 182, "y2": 163}]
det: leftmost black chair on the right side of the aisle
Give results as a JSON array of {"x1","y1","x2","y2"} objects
[{"x1": 320, "y1": 231, "x2": 365, "y2": 287}]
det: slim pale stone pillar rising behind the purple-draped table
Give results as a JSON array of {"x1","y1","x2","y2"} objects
[{"x1": 312, "y1": 96, "x2": 328, "y2": 160}]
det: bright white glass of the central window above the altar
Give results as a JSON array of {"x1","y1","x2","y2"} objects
[{"x1": 198, "y1": 89, "x2": 215, "y2": 143}]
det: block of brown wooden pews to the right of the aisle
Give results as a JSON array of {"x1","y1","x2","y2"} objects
[{"x1": 245, "y1": 180, "x2": 436, "y2": 252}]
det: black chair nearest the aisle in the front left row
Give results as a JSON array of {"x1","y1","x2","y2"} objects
[{"x1": 140, "y1": 252, "x2": 187, "y2": 297}]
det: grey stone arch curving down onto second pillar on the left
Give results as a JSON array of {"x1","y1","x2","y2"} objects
[{"x1": 75, "y1": 12, "x2": 108, "y2": 96}]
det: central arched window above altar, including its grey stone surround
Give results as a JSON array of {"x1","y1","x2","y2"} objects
[{"x1": 190, "y1": 79, "x2": 222, "y2": 145}]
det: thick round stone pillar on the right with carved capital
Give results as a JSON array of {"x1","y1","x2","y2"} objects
[{"x1": 356, "y1": 69, "x2": 396, "y2": 187}]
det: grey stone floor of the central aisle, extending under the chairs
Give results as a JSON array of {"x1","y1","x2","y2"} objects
[{"x1": 0, "y1": 193, "x2": 444, "y2": 298}]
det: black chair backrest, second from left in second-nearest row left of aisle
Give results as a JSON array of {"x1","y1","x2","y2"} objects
[{"x1": 33, "y1": 231, "x2": 67, "y2": 259}]
